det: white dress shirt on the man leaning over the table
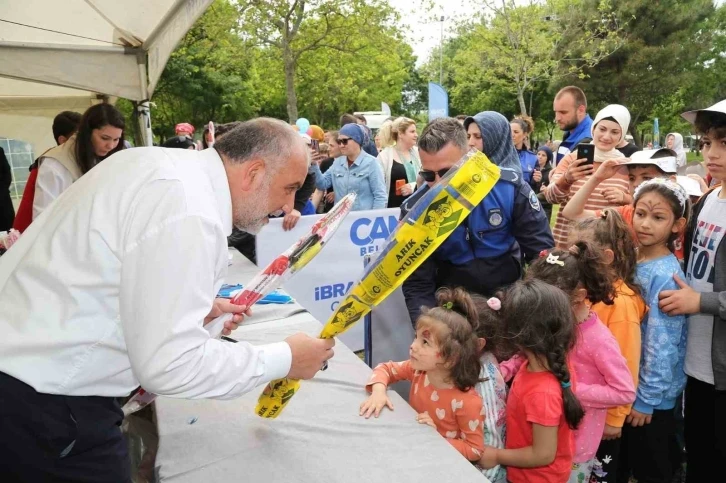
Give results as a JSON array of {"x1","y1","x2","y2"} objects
[{"x1": 0, "y1": 148, "x2": 292, "y2": 398}]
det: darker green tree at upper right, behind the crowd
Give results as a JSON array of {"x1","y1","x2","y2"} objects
[{"x1": 559, "y1": 0, "x2": 724, "y2": 145}]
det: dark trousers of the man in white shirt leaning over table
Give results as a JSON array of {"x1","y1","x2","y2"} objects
[{"x1": 0, "y1": 372, "x2": 131, "y2": 483}]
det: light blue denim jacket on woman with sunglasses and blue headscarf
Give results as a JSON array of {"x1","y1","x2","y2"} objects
[{"x1": 313, "y1": 150, "x2": 388, "y2": 211}]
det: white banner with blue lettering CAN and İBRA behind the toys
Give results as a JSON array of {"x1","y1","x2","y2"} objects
[{"x1": 257, "y1": 208, "x2": 400, "y2": 351}]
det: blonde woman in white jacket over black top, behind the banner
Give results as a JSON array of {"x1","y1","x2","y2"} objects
[{"x1": 378, "y1": 117, "x2": 421, "y2": 208}]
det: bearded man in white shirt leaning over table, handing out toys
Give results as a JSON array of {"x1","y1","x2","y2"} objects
[{"x1": 0, "y1": 119, "x2": 333, "y2": 482}]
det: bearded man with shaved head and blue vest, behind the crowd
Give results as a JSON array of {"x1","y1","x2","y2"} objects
[{"x1": 553, "y1": 86, "x2": 592, "y2": 163}]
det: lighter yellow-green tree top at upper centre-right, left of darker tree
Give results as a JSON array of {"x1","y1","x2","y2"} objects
[{"x1": 452, "y1": 0, "x2": 622, "y2": 115}]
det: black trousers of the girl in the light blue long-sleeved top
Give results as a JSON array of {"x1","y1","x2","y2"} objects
[{"x1": 617, "y1": 409, "x2": 680, "y2": 483}]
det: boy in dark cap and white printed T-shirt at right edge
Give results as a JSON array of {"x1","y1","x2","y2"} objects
[{"x1": 659, "y1": 100, "x2": 726, "y2": 483}]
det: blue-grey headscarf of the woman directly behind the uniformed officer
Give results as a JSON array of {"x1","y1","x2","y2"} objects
[{"x1": 464, "y1": 111, "x2": 522, "y2": 178}]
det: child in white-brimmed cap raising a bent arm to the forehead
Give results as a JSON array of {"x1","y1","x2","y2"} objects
[{"x1": 562, "y1": 148, "x2": 683, "y2": 260}]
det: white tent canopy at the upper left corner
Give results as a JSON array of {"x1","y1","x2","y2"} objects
[{"x1": 0, "y1": 0, "x2": 213, "y2": 152}]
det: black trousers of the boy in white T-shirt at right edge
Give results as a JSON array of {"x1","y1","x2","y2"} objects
[{"x1": 685, "y1": 377, "x2": 726, "y2": 483}]
